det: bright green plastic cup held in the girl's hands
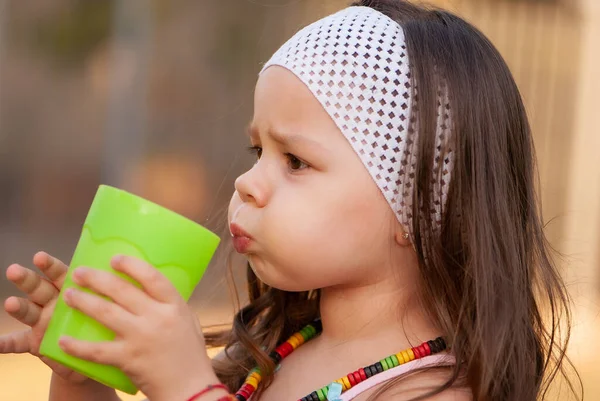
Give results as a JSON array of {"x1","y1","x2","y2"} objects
[{"x1": 40, "y1": 185, "x2": 220, "y2": 394}]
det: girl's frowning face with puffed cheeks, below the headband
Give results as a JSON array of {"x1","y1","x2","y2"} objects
[{"x1": 229, "y1": 66, "x2": 399, "y2": 291}]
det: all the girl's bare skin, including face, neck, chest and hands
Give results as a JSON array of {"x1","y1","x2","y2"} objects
[{"x1": 0, "y1": 67, "x2": 470, "y2": 401}]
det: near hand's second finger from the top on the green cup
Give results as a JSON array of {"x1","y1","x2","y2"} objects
[{"x1": 73, "y1": 267, "x2": 156, "y2": 315}]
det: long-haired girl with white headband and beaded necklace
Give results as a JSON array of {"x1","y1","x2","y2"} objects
[{"x1": 0, "y1": 0, "x2": 577, "y2": 401}]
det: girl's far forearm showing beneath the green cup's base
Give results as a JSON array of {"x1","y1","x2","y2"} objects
[{"x1": 48, "y1": 374, "x2": 121, "y2": 401}]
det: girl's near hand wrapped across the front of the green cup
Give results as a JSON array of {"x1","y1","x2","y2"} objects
[{"x1": 60, "y1": 256, "x2": 217, "y2": 401}]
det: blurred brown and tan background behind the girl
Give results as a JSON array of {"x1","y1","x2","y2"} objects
[{"x1": 0, "y1": 0, "x2": 600, "y2": 401}]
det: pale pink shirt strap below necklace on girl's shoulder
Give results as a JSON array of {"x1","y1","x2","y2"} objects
[{"x1": 340, "y1": 354, "x2": 455, "y2": 401}]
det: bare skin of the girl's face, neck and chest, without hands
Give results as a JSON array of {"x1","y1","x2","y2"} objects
[{"x1": 229, "y1": 66, "x2": 466, "y2": 401}]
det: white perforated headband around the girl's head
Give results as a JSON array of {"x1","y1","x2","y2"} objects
[{"x1": 261, "y1": 7, "x2": 453, "y2": 238}]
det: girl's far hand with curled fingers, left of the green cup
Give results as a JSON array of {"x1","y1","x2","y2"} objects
[{"x1": 0, "y1": 252, "x2": 89, "y2": 383}]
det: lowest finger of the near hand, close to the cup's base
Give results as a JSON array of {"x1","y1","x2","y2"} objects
[{"x1": 58, "y1": 336, "x2": 125, "y2": 366}]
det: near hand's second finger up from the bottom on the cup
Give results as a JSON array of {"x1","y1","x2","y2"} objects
[{"x1": 65, "y1": 288, "x2": 135, "y2": 334}]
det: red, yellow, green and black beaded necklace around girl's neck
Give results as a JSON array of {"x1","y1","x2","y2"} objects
[{"x1": 235, "y1": 319, "x2": 446, "y2": 401}]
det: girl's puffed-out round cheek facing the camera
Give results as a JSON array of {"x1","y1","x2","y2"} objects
[{"x1": 256, "y1": 177, "x2": 393, "y2": 291}]
